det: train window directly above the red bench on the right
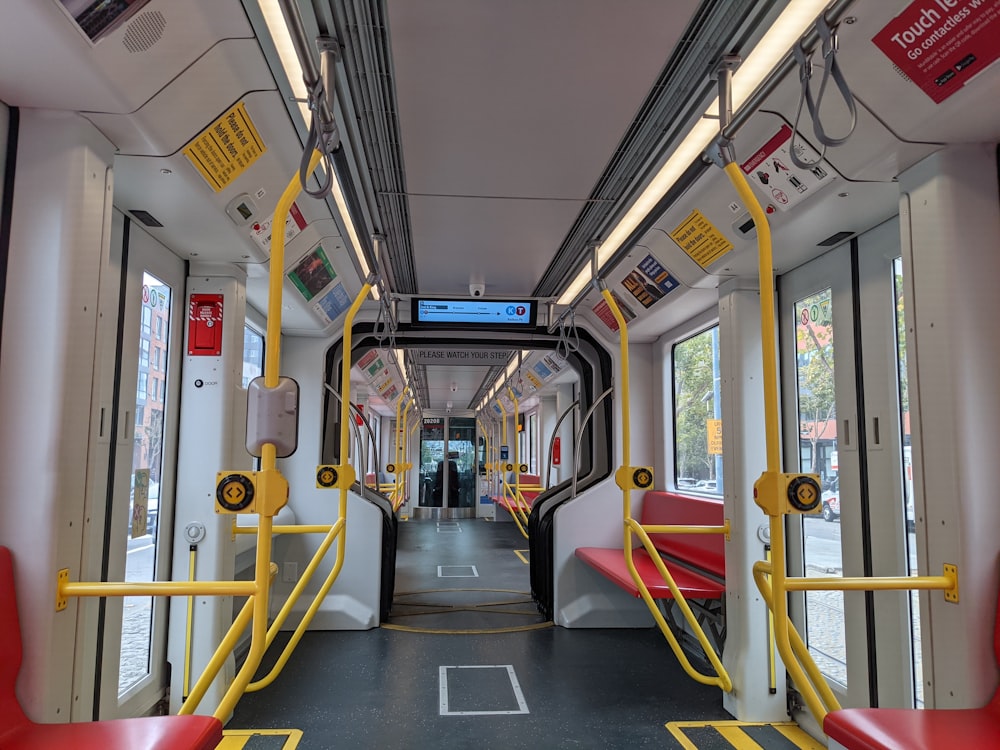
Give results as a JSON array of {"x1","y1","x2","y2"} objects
[{"x1": 672, "y1": 326, "x2": 723, "y2": 495}]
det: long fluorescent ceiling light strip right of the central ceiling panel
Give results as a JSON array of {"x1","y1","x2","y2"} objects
[{"x1": 558, "y1": 0, "x2": 828, "y2": 305}]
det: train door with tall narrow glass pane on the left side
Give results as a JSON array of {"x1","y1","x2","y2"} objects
[{"x1": 99, "y1": 224, "x2": 184, "y2": 718}]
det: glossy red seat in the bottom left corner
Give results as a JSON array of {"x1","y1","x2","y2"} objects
[{"x1": 0, "y1": 547, "x2": 222, "y2": 750}]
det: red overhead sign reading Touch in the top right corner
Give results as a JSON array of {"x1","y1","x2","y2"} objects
[{"x1": 872, "y1": 0, "x2": 1000, "y2": 104}]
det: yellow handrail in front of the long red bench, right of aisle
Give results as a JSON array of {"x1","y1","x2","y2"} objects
[{"x1": 601, "y1": 288, "x2": 733, "y2": 693}]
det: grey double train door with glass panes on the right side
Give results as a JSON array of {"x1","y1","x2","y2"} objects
[{"x1": 779, "y1": 220, "x2": 922, "y2": 707}]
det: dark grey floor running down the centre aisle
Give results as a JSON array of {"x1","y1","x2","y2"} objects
[{"x1": 229, "y1": 519, "x2": 731, "y2": 750}]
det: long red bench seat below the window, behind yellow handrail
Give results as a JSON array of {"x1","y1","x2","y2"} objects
[{"x1": 576, "y1": 490, "x2": 726, "y2": 599}]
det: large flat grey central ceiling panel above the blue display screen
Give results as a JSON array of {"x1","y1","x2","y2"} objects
[{"x1": 389, "y1": 0, "x2": 696, "y2": 295}]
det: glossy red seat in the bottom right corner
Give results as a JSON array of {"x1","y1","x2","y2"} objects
[{"x1": 823, "y1": 580, "x2": 1000, "y2": 750}]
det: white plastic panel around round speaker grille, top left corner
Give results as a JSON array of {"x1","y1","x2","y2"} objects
[{"x1": 0, "y1": 0, "x2": 253, "y2": 113}]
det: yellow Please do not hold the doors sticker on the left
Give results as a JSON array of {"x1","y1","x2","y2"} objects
[{"x1": 184, "y1": 102, "x2": 267, "y2": 193}]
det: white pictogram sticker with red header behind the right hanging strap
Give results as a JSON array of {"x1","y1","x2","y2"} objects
[{"x1": 740, "y1": 125, "x2": 833, "y2": 211}]
